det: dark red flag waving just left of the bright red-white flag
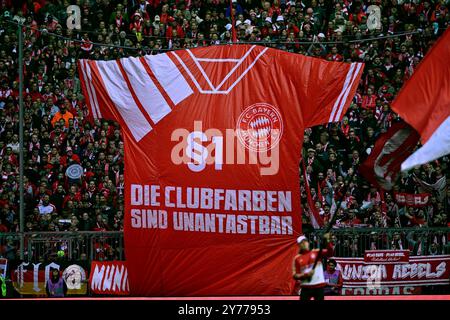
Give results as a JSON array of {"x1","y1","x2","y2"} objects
[{"x1": 359, "y1": 122, "x2": 419, "y2": 190}]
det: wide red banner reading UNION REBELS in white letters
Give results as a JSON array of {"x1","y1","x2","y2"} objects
[{"x1": 335, "y1": 255, "x2": 450, "y2": 288}]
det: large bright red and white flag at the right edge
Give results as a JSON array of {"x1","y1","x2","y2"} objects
[{"x1": 392, "y1": 29, "x2": 450, "y2": 170}]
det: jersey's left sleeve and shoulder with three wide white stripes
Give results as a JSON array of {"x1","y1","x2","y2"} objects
[{"x1": 78, "y1": 54, "x2": 192, "y2": 141}]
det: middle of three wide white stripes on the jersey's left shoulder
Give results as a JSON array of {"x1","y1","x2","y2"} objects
[{"x1": 121, "y1": 58, "x2": 171, "y2": 124}]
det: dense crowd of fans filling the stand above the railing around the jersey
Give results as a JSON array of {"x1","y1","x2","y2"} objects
[{"x1": 0, "y1": 0, "x2": 450, "y2": 260}]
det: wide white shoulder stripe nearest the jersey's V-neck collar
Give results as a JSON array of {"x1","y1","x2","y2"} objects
[{"x1": 144, "y1": 53, "x2": 194, "y2": 105}]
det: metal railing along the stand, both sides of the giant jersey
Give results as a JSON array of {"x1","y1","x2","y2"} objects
[{"x1": 0, "y1": 227, "x2": 450, "y2": 262}]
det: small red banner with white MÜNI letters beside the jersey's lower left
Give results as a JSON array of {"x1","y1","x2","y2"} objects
[{"x1": 89, "y1": 261, "x2": 130, "y2": 295}]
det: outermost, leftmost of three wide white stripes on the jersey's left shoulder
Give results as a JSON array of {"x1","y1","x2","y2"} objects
[{"x1": 97, "y1": 61, "x2": 152, "y2": 141}]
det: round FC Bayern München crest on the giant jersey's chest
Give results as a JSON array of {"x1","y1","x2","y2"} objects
[{"x1": 236, "y1": 103, "x2": 283, "y2": 152}]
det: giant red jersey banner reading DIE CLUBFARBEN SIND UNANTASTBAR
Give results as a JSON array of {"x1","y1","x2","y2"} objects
[{"x1": 79, "y1": 45, "x2": 363, "y2": 296}]
